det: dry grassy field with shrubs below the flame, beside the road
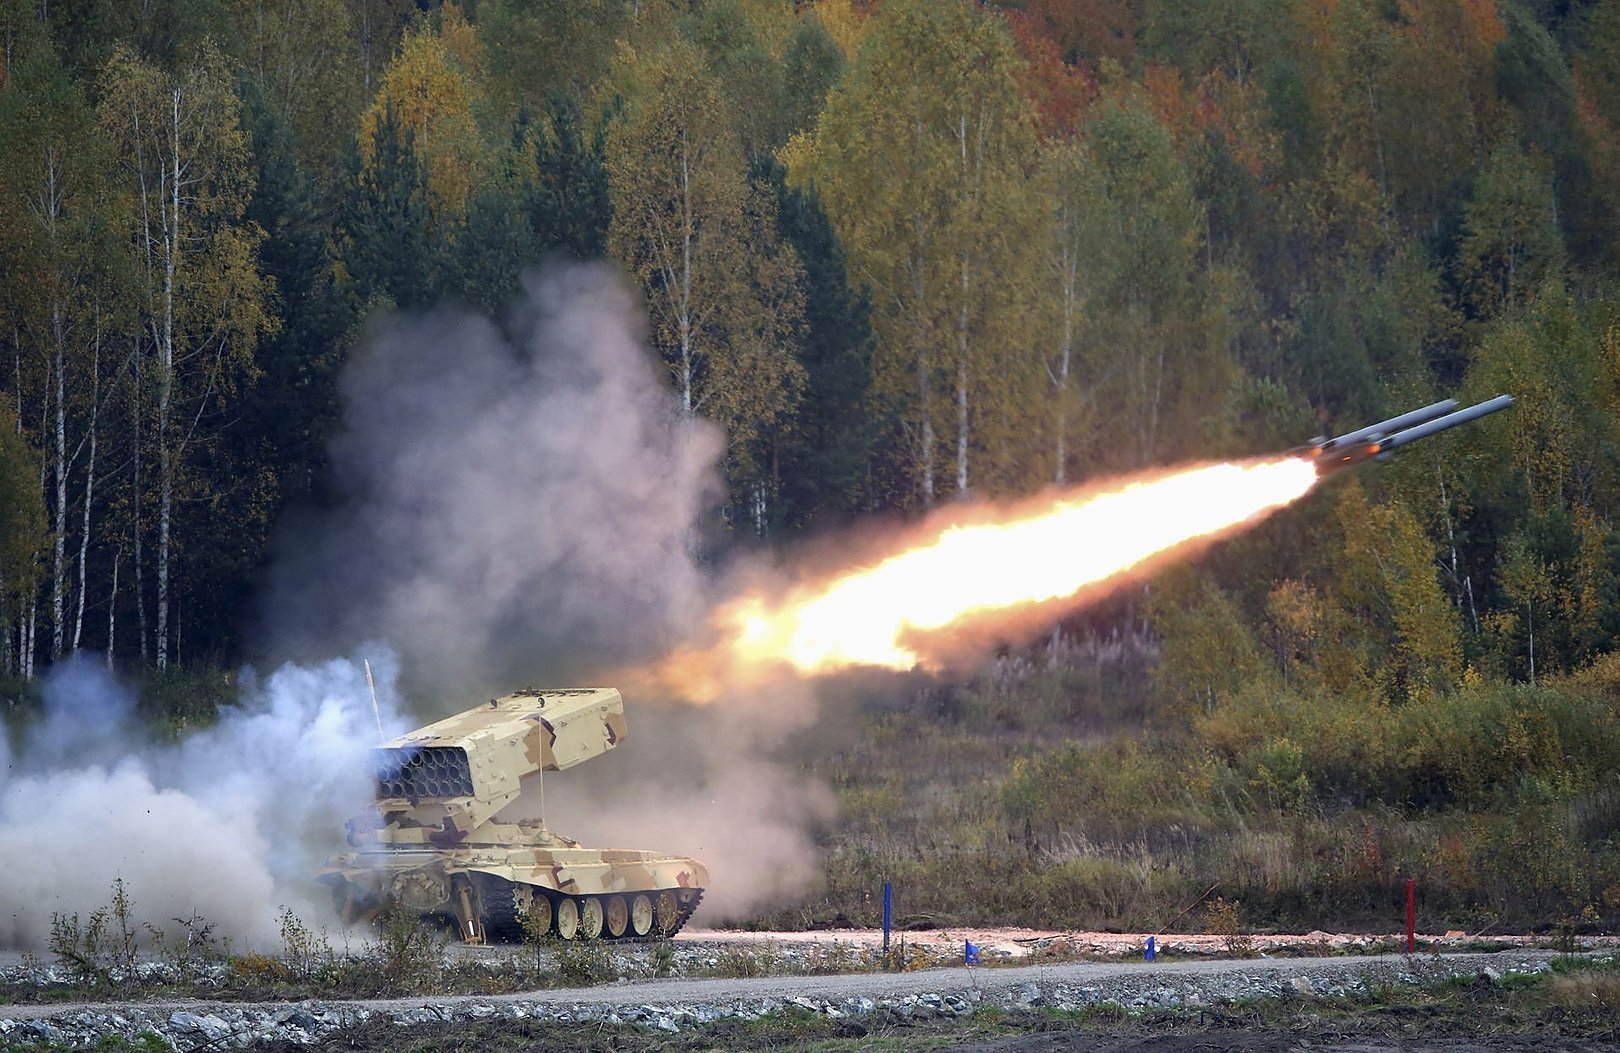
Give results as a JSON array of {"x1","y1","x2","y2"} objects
[{"x1": 764, "y1": 645, "x2": 1620, "y2": 932}]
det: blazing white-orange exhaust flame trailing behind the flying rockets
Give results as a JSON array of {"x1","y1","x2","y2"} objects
[{"x1": 644, "y1": 457, "x2": 1317, "y2": 698}]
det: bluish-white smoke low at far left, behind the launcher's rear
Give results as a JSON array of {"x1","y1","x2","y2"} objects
[{"x1": 0, "y1": 650, "x2": 402, "y2": 949}]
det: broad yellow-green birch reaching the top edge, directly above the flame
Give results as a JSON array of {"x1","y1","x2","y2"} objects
[{"x1": 784, "y1": 0, "x2": 1034, "y2": 504}]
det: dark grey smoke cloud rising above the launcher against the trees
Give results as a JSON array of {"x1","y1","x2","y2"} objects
[{"x1": 267, "y1": 266, "x2": 721, "y2": 693}]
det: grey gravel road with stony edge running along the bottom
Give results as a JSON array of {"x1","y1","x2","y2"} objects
[{"x1": 0, "y1": 951, "x2": 1599, "y2": 1053}]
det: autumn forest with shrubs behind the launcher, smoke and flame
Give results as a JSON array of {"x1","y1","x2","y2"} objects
[{"x1": 0, "y1": 0, "x2": 1620, "y2": 922}]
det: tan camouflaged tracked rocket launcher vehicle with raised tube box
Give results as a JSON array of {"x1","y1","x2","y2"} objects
[{"x1": 321, "y1": 687, "x2": 708, "y2": 943}]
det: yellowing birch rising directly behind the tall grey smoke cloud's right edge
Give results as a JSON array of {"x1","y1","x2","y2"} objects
[{"x1": 608, "y1": 39, "x2": 804, "y2": 502}]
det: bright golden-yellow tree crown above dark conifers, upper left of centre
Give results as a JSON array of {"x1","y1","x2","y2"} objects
[{"x1": 360, "y1": 16, "x2": 483, "y2": 219}]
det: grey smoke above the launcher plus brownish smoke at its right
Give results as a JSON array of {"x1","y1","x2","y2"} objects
[{"x1": 266, "y1": 266, "x2": 829, "y2": 922}]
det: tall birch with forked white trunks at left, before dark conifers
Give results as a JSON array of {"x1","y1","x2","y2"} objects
[{"x1": 100, "y1": 44, "x2": 274, "y2": 669}]
